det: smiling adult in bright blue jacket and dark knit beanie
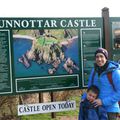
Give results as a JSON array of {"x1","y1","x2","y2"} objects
[{"x1": 83, "y1": 48, "x2": 120, "y2": 120}]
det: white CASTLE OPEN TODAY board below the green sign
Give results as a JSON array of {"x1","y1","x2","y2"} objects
[{"x1": 18, "y1": 101, "x2": 76, "y2": 116}]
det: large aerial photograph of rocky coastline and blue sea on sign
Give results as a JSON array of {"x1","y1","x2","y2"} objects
[{"x1": 13, "y1": 29, "x2": 79, "y2": 77}]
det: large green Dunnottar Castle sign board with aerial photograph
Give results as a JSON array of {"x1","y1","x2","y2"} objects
[{"x1": 0, "y1": 18, "x2": 102, "y2": 95}]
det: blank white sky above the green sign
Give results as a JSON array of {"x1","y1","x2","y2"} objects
[{"x1": 0, "y1": 0, "x2": 120, "y2": 17}]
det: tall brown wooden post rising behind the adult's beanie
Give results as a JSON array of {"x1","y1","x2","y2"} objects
[{"x1": 102, "y1": 7, "x2": 112, "y2": 58}]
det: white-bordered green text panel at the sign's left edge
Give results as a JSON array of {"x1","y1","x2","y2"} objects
[{"x1": 0, "y1": 30, "x2": 13, "y2": 94}]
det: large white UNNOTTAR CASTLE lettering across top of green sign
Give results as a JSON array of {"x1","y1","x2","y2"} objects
[{"x1": 0, "y1": 19, "x2": 97, "y2": 28}]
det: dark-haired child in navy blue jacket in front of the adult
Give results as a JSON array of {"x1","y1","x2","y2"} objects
[{"x1": 78, "y1": 85, "x2": 108, "y2": 120}]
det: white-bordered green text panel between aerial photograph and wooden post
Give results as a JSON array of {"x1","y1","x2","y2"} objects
[{"x1": 80, "y1": 28, "x2": 102, "y2": 87}]
